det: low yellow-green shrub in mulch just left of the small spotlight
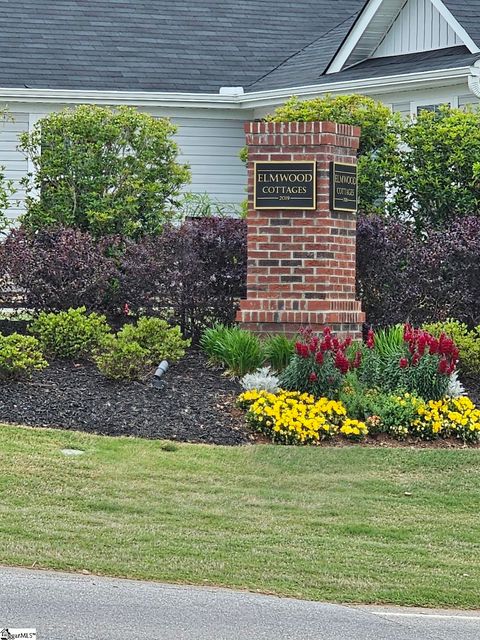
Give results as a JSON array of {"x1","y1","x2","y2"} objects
[{"x1": 95, "y1": 336, "x2": 153, "y2": 380}]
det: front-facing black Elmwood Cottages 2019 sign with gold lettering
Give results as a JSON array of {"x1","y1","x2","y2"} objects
[{"x1": 254, "y1": 160, "x2": 317, "y2": 209}]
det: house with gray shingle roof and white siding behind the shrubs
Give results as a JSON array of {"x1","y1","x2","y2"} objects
[{"x1": 0, "y1": 0, "x2": 480, "y2": 216}]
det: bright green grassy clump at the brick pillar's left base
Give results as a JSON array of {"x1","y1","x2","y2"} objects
[{"x1": 201, "y1": 325, "x2": 265, "y2": 377}]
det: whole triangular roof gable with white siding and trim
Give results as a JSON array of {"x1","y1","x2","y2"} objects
[{"x1": 327, "y1": 0, "x2": 480, "y2": 73}]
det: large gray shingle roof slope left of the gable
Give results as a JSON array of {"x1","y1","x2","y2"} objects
[{"x1": 0, "y1": 0, "x2": 364, "y2": 92}]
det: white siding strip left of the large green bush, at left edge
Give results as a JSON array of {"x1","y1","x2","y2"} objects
[{"x1": 0, "y1": 111, "x2": 28, "y2": 218}]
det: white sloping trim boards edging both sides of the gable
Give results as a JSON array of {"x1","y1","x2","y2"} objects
[{"x1": 326, "y1": 0, "x2": 480, "y2": 74}]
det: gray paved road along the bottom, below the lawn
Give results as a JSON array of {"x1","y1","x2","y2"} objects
[{"x1": 0, "y1": 567, "x2": 480, "y2": 640}]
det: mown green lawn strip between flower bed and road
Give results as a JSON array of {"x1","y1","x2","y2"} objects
[{"x1": 0, "y1": 427, "x2": 480, "y2": 608}]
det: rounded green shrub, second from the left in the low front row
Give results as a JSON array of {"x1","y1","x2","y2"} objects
[{"x1": 29, "y1": 307, "x2": 110, "y2": 358}]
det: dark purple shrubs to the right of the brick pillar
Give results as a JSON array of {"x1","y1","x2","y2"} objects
[{"x1": 357, "y1": 216, "x2": 480, "y2": 326}]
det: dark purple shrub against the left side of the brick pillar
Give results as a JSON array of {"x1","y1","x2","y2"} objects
[{"x1": 119, "y1": 218, "x2": 247, "y2": 341}]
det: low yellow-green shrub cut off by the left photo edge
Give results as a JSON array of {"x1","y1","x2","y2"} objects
[{"x1": 0, "y1": 333, "x2": 48, "y2": 380}]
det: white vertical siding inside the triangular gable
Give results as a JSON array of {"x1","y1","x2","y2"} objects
[{"x1": 372, "y1": 0, "x2": 463, "y2": 58}]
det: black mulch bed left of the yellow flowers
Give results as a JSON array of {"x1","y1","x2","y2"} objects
[{"x1": 0, "y1": 351, "x2": 252, "y2": 445}]
